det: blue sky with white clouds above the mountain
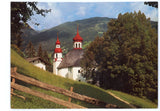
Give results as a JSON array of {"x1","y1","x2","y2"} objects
[{"x1": 28, "y1": 2, "x2": 158, "y2": 31}]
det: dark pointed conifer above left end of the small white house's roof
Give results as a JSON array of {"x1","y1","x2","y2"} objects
[{"x1": 25, "y1": 41, "x2": 36, "y2": 57}]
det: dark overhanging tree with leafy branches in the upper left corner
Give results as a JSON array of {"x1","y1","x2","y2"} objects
[{"x1": 11, "y1": 2, "x2": 51, "y2": 47}]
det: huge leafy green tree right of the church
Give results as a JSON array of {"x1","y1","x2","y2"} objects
[{"x1": 82, "y1": 11, "x2": 158, "y2": 100}]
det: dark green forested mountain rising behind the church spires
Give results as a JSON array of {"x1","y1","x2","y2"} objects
[{"x1": 21, "y1": 17, "x2": 111, "y2": 52}]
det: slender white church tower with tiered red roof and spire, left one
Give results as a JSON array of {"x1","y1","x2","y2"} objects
[{"x1": 53, "y1": 33, "x2": 63, "y2": 75}]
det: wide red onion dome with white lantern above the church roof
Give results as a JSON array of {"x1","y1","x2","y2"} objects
[{"x1": 73, "y1": 25, "x2": 83, "y2": 49}]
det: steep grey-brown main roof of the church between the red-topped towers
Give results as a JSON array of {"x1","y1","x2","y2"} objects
[{"x1": 58, "y1": 49, "x2": 84, "y2": 69}]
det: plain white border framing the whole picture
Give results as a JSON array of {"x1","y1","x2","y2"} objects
[{"x1": 0, "y1": 0, "x2": 160, "y2": 111}]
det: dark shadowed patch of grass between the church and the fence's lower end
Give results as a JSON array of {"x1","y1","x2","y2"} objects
[{"x1": 64, "y1": 82, "x2": 130, "y2": 108}]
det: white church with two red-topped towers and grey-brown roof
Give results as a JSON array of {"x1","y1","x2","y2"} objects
[{"x1": 53, "y1": 27, "x2": 85, "y2": 82}]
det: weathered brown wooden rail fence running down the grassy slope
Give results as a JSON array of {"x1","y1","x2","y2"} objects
[{"x1": 11, "y1": 67, "x2": 118, "y2": 108}]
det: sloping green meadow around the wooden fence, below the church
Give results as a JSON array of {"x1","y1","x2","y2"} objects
[{"x1": 11, "y1": 49, "x2": 156, "y2": 108}]
